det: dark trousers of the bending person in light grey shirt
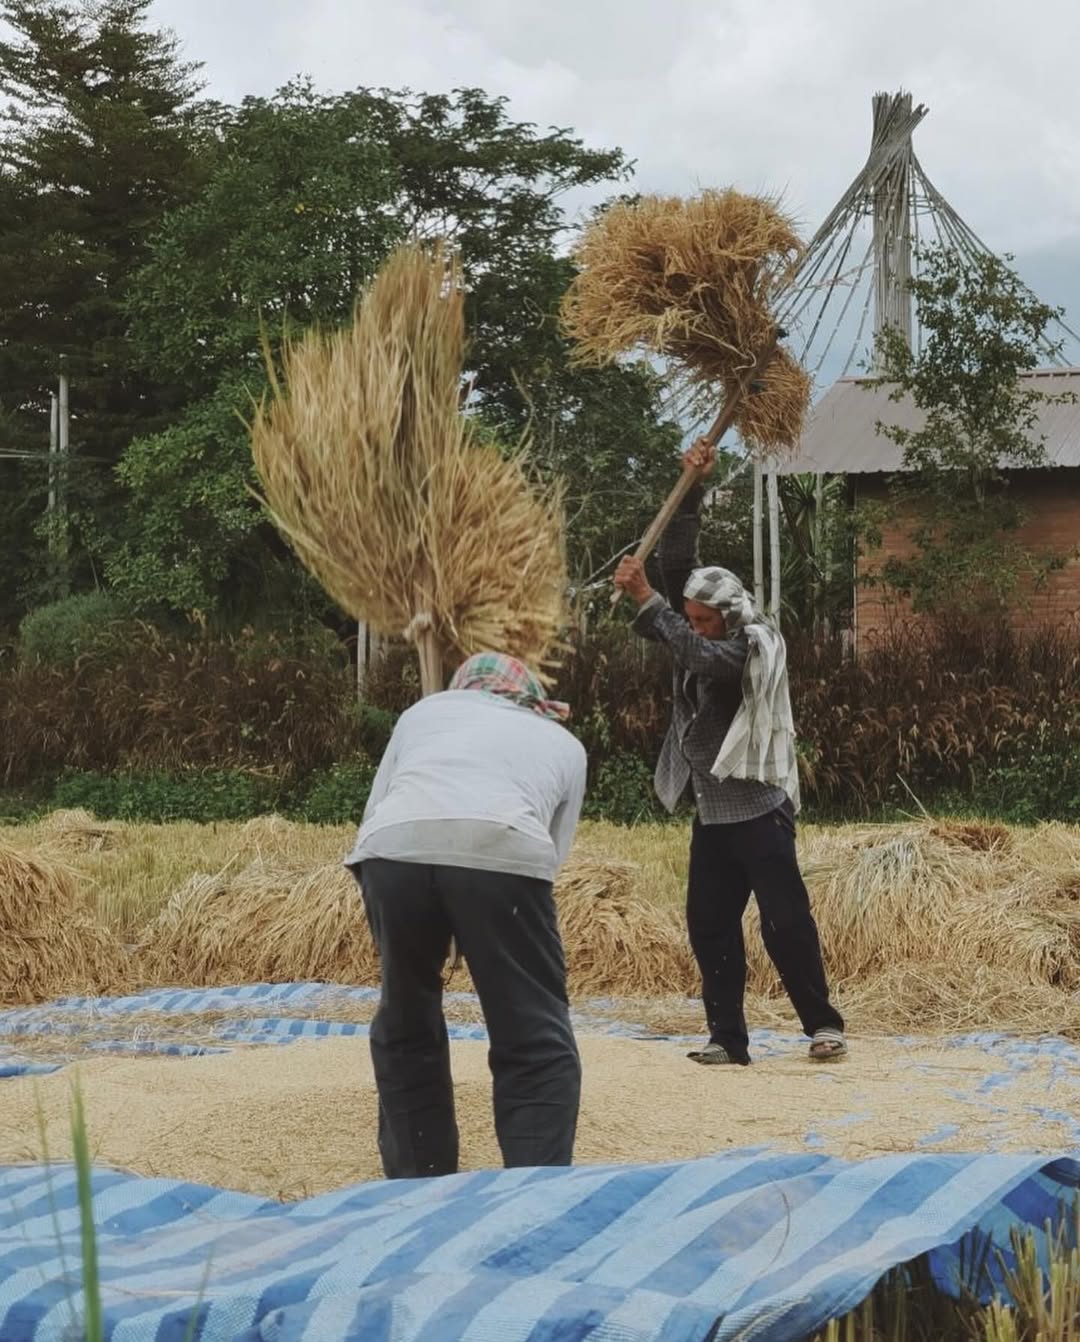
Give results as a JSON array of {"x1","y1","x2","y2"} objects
[{"x1": 357, "y1": 859, "x2": 581, "y2": 1178}]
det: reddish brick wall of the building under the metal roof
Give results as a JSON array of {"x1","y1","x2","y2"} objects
[{"x1": 855, "y1": 467, "x2": 1080, "y2": 648}]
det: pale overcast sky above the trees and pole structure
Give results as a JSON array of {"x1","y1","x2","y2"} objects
[{"x1": 152, "y1": 0, "x2": 1080, "y2": 351}]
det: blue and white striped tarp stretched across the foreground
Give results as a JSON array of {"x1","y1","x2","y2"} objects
[{"x1": 0, "y1": 1150, "x2": 1080, "y2": 1342}]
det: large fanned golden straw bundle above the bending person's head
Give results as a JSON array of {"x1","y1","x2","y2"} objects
[{"x1": 252, "y1": 247, "x2": 566, "y2": 668}]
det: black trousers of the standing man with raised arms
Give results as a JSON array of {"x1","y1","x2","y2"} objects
[{"x1": 687, "y1": 808, "x2": 844, "y2": 1062}]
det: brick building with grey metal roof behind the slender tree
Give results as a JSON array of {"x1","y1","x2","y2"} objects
[{"x1": 779, "y1": 368, "x2": 1080, "y2": 648}]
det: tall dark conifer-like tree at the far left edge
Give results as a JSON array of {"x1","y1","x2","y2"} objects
[{"x1": 0, "y1": 0, "x2": 207, "y2": 620}]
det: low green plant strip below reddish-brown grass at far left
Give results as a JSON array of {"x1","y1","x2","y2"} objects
[{"x1": 51, "y1": 769, "x2": 278, "y2": 824}]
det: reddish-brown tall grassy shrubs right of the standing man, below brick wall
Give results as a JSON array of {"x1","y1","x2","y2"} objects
[{"x1": 789, "y1": 624, "x2": 1080, "y2": 819}]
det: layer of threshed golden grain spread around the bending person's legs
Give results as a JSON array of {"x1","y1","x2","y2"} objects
[{"x1": 0, "y1": 1032, "x2": 1072, "y2": 1197}]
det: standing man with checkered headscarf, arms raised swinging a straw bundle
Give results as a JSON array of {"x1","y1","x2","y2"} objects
[{"x1": 614, "y1": 442, "x2": 847, "y2": 1066}]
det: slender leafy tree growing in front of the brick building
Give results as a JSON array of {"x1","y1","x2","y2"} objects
[{"x1": 875, "y1": 248, "x2": 1061, "y2": 612}]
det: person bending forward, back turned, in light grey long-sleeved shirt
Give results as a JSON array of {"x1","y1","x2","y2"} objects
[{"x1": 346, "y1": 652, "x2": 585, "y2": 1178}]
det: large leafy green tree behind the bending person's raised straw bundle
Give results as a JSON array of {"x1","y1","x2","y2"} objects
[{"x1": 109, "y1": 83, "x2": 675, "y2": 613}]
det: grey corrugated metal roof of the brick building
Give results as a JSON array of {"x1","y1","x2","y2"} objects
[{"x1": 779, "y1": 368, "x2": 1080, "y2": 475}]
